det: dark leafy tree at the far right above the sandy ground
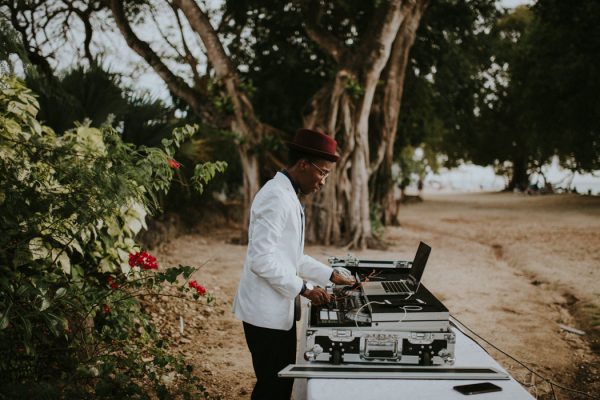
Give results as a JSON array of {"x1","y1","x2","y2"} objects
[{"x1": 459, "y1": 0, "x2": 600, "y2": 190}]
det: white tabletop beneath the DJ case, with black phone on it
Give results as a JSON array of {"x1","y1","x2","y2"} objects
[{"x1": 294, "y1": 330, "x2": 533, "y2": 400}]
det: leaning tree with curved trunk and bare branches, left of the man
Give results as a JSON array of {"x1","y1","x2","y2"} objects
[{"x1": 2, "y1": 0, "x2": 274, "y2": 241}]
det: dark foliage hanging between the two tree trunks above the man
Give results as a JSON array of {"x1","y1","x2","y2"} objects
[{"x1": 222, "y1": 0, "x2": 332, "y2": 134}]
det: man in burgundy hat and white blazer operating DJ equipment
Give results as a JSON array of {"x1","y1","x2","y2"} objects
[{"x1": 233, "y1": 129, "x2": 354, "y2": 400}]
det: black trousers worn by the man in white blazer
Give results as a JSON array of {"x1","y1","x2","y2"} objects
[{"x1": 244, "y1": 322, "x2": 296, "y2": 400}]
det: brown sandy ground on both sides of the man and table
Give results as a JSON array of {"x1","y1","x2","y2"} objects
[{"x1": 151, "y1": 193, "x2": 600, "y2": 399}]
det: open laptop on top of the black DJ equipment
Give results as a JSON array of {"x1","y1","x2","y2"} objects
[{"x1": 361, "y1": 242, "x2": 431, "y2": 296}]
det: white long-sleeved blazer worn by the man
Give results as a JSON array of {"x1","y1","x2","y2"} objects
[{"x1": 233, "y1": 172, "x2": 332, "y2": 330}]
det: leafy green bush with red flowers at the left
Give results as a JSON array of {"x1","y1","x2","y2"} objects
[{"x1": 0, "y1": 77, "x2": 225, "y2": 398}]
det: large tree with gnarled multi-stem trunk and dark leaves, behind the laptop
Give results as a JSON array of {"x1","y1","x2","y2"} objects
[{"x1": 221, "y1": 0, "x2": 432, "y2": 247}]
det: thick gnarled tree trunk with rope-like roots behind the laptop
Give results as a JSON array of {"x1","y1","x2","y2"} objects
[{"x1": 304, "y1": 0, "x2": 426, "y2": 248}]
